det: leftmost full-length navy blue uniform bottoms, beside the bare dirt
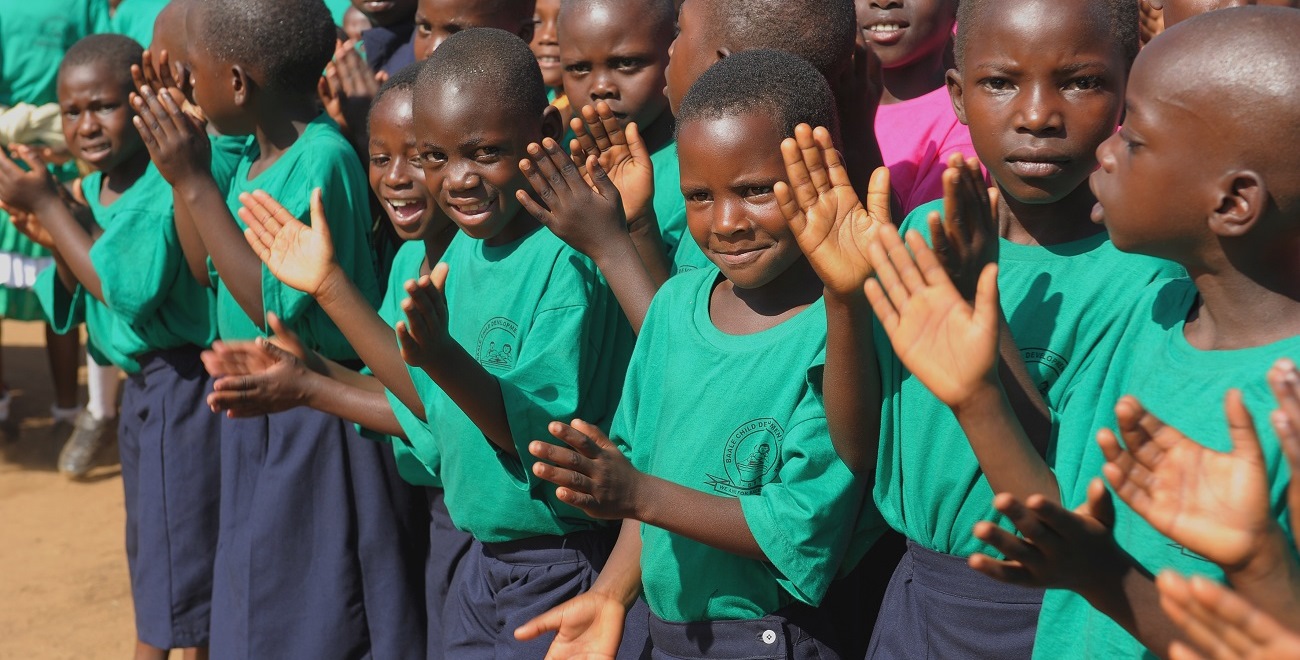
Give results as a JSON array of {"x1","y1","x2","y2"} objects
[{"x1": 118, "y1": 348, "x2": 221, "y2": 648}]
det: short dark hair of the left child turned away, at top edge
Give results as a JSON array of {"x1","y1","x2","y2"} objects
[{"x1": 195, "y1": 0, "x2": 335, "y2": 94}]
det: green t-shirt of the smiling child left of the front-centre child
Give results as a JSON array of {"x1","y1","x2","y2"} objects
[{"x1": 415, "y1": 229, "x2": 631, "y2": 543}]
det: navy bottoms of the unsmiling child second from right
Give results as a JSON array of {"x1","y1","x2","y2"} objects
[{"x1": 867, "y1": 542, "x2": 1043, "y2": 660}]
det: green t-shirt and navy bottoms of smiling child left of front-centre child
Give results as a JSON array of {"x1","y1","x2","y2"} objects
[{"x1": 410, "y1": 227, "x2": 632, "y2": 659}]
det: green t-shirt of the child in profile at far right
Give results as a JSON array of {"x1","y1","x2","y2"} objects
[{"x1": 1034, "y1": 278, "x2": 1300, "y2": 659}]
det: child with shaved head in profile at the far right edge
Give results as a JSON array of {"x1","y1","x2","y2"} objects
[{"x1": 956, "y1": 8, "x2": 1300, "y2": 657}]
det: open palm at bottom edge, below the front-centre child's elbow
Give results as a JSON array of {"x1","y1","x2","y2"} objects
[{"x1": 515, "y1": 591, "x2": 628, "y2": 660}]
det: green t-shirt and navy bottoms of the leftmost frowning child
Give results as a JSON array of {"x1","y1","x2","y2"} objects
[{"x1": 36, "y1": 164, "x2": 220, "y2": 648}]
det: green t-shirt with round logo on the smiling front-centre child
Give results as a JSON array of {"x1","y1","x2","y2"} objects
[{"x1": 611, "y1": 269, "x2": 884, "y2": 621}]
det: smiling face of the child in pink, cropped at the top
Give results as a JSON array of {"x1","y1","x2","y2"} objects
[{"x1": 854, "y1": 0, "x2": 957, "y2": 69}]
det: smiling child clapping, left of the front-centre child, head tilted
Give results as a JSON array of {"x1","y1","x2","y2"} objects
[{"x1": 384, "y1": 29, "x2": 631, "y2": 659}]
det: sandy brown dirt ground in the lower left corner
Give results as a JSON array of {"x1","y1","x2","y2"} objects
[{"x1": 0, "y1": 321, "x2": 135, "y2": 660}]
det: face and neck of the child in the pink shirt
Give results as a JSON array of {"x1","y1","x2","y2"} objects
[{"x1": 853, "y1": 0, "x2": 957, "y2": 104}]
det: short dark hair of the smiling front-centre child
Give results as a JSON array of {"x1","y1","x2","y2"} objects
[{"x1": 677, "y1": 51, "x2": 840, "y2": 138}]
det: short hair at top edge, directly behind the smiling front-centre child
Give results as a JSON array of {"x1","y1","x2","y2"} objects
[{"x1": 707, "y1": 0, "x2": 857, "y2": 79}]
